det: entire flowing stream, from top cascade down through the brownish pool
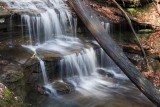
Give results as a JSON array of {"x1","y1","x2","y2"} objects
[{"x1": 1, "y1": 0, "x2": 153, "y2": 107}]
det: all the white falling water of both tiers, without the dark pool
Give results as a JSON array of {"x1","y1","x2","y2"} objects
[{"x1": 4, "y1": 0, "x2": 128, "y2": 96}]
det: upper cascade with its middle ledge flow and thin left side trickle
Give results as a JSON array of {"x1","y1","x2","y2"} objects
[{"x1": 4, "y1": 0, "x2": 78, "y2": 94}]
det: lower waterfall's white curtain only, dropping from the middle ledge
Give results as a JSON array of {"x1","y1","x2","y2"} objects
[{"x1": 60, "y1": 48, "x2": 97, "y2": 86}]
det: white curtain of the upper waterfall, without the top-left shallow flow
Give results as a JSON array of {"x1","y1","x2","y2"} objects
[{"x1": 20, "y1": 0, "x2": 76, "y2": 45}]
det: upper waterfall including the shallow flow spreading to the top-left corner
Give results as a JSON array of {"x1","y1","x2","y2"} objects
[{"x1": 1, "y1": 0, "x2": 74, "y2": 45}]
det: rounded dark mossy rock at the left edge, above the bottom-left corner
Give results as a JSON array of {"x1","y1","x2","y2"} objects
[{"x1": 1, "y1": 64, "x2": 24, "y2": 82}]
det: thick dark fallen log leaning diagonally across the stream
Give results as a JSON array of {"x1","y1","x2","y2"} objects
[{"x1": 68, "y1": 0, "x2": 160, "y2": 107}]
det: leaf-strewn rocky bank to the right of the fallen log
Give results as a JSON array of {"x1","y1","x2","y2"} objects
[{"x1": 90, "y1": 0, "x2": 160, "y2": 88}]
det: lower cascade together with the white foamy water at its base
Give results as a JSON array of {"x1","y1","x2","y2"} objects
[{"x1": 60, "y1": 48, "x2": 128, "y2": 97}]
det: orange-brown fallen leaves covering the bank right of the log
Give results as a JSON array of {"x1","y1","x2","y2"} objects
[{"x1": 90, "y1": 3, "x2": 160, "y2": 88}]
